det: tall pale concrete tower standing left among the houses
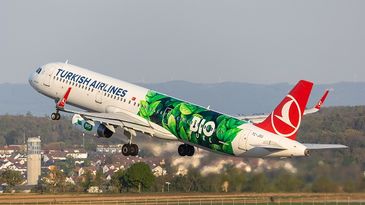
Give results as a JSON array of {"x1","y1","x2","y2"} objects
[{"x1": 27, "y1": 137, "x2": 41, "y2": 185}]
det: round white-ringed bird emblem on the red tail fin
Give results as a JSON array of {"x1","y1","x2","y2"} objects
[{"x1": 271, "y1": 95, "x2": 302, "y2": 137}]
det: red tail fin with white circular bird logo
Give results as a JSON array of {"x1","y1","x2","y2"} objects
[{"x1": 256, "y1": 80, "x2": 313, "y2": 140}]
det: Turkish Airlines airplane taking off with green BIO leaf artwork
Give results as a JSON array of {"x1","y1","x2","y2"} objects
[{"x1": 29, "y1": 62, "x2": 347, "y2": 158}]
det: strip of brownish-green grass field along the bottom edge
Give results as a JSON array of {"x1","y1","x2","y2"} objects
[{"x1": 0, "y1": 193, "x2": 365, "y2": 205}]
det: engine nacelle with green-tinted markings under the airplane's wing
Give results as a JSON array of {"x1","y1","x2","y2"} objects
[{"x1": 72, "y1": 114, "x2": 115, "y2": 138}]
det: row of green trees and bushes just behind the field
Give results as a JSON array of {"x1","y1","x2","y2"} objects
[{"x1": 0, "y1": 162, "x2": 365, "y2": 193}]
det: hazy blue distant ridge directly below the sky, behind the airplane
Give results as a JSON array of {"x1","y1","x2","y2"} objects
[{"x1": 0, "y1": 81, "x2": 365, "y2": 116}]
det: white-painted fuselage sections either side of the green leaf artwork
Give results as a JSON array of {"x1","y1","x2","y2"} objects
[{"x1": 29, "y1": 63, "x2": 306, "y2": 157}]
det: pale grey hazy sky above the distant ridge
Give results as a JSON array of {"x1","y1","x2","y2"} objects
[{"x1": 0, "y1": 0, "x2": 365, "y2": 84}]
